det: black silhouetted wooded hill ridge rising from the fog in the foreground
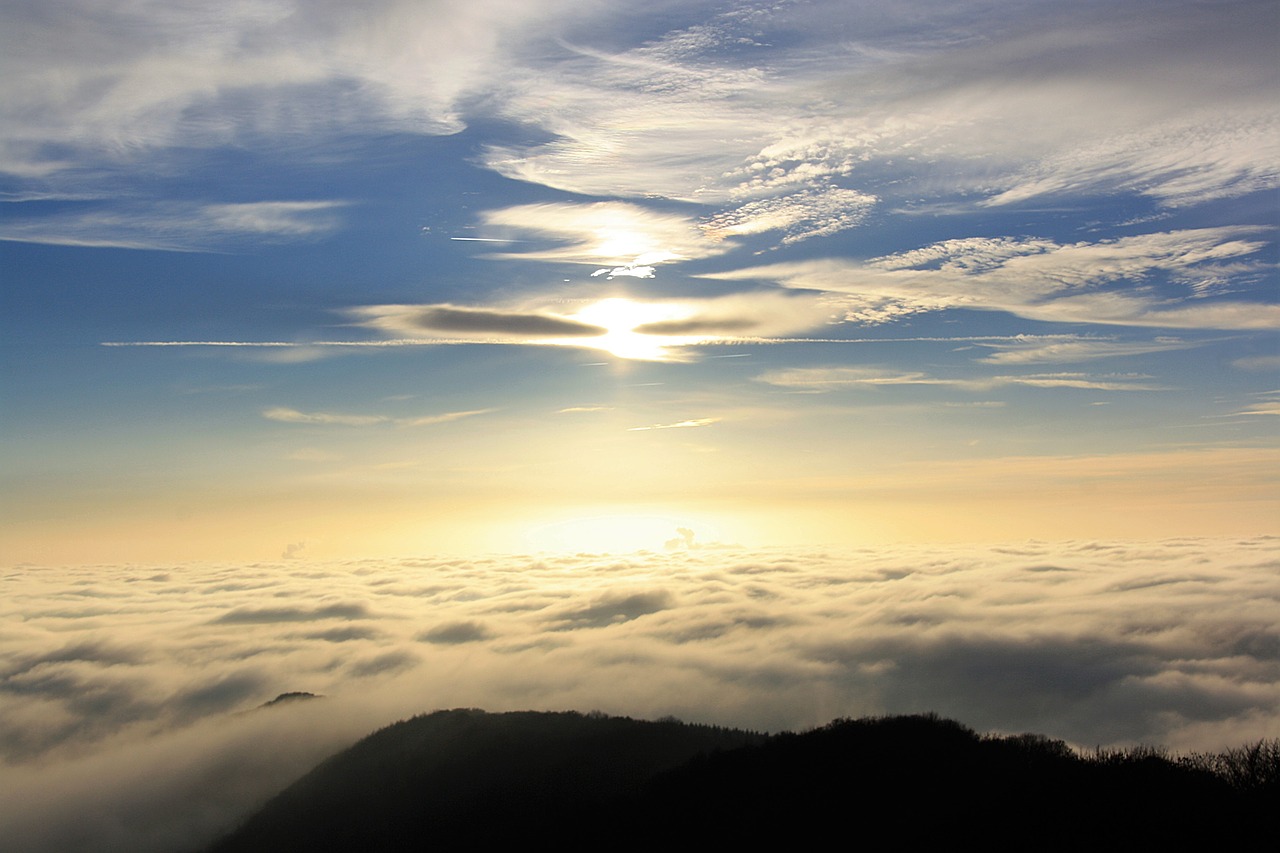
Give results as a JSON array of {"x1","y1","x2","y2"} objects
[{"x1": 211, "y1": 710, "x2": 1280, "y2": 853}]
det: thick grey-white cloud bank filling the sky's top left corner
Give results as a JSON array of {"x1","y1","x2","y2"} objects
[{"x1": 0, "y1": 0, "x2": 591, "y2": 179}]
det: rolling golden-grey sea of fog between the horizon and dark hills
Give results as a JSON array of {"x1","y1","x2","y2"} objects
[{"x1": 0, "y1": 537, "x2": 1280, "y2": 853}]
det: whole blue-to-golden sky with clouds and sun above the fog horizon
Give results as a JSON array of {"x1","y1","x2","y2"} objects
[{"x1": 0, "y1": 0, "x2": 1280, "y2": 561}]
